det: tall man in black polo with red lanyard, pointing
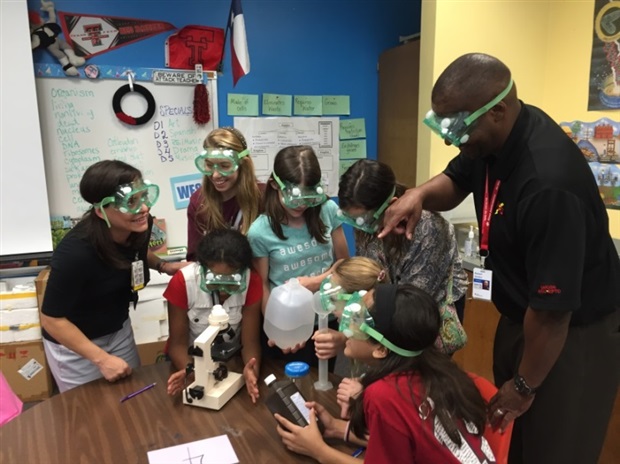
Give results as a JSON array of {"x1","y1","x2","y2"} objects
[{"x1": 379, "y1": 53, "x2": 620, "y2": 464}]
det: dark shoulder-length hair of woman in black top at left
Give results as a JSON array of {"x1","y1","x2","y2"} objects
[{"x1": 80, "y1": 160, "x2": 150, "y2": 269}]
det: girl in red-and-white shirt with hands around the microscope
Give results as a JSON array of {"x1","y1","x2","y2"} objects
[{"x1": 164, "y1": 229, "x2": 263, "y2": 402}]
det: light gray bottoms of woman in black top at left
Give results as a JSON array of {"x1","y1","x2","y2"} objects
[{"x1": 43, "y1": 318, "x2": 140, "y2": 393}]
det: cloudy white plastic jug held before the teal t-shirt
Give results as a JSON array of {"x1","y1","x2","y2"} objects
[{"x1": 263, "y1": 279, "x2": 315, "y2": 349}]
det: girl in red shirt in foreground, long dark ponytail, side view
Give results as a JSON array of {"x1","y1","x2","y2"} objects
[{"x1": 276, "y1": 284, "x2": 495, "y2": 464}]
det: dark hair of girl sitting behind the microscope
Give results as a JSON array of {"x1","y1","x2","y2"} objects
[{"x1": 196, "y1": 229, "x2": 252, "y2": 270}]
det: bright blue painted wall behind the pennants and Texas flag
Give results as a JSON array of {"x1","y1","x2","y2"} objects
[{"x1": 28, "y1": 0, "x2": 421, "y2": 158}]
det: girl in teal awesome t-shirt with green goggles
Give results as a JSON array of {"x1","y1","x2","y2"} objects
[{"x1": 248, "y1": 146, "x2": 349, "y2": 363}]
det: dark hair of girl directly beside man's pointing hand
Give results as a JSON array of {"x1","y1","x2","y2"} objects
[{"x1": 338, "y1": 159, "x2": 409, "y2": 260}]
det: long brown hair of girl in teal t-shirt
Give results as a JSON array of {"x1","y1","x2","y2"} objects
[{"x1": 263, "y1": 145, "x2": 327, "y2": 243}]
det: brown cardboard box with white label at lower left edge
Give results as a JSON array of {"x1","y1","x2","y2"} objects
[{"x1": 0, "y1": 340, "x2": 53, "y2": 401}]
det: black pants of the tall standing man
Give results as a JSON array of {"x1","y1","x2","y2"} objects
[{"x1": 493, "y1": 311, "x2": 620, "y2": 464}]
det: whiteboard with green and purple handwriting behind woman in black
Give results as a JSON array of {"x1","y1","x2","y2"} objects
[{"x1": 36, "y1": 73, "x2": 218, "y2": 246}]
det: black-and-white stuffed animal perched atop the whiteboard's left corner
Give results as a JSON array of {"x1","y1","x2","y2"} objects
[{"x1": 29, "y1": 0, "x2": 86, "y2": 76}]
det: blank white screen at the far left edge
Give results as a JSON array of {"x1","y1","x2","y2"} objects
[{"x1": 0, "y1": 0, "x2": 52, "y2": 257}]
